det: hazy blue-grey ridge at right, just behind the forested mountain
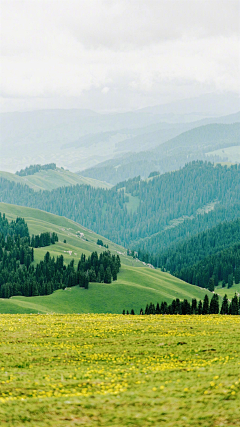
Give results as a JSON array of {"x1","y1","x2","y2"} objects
[{"x1": 81, "y1": 123, "x2": 240, "y2": 184}]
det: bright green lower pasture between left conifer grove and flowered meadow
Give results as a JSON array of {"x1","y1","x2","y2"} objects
[{"x1": 0, "y1": 265, "x2": 211, "y2": 314}]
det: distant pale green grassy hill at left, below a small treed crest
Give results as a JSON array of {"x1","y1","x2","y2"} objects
[{"x1": 0, "y1": 169, "x2": 111, "y2": 191}]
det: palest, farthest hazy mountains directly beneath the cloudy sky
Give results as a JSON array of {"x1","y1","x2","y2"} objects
[{"x1": 0, "y1": 94, "x2": 240, "y2": 175}]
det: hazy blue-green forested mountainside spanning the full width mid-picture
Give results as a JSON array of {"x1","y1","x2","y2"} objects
[{"x1": 0, "y1": 161, "x2": 240, "y2": 253}]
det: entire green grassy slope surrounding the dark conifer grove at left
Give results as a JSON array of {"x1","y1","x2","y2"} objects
[{"x1": 0, "y1": 203, "x2": 213, "y2": 313}]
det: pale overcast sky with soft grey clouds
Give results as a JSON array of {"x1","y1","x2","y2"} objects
[{"x1": 1, "y1": 0, "x2": 240, "y2": 111}]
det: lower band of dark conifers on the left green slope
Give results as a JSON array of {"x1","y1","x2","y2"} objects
[{"x1": 0, "y1": 249, "x2": 121, "y2": 298}]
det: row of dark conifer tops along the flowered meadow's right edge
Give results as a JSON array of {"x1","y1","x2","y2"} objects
[{"x1": 123, "y1": 294, "x2": 240, "y2": 315}]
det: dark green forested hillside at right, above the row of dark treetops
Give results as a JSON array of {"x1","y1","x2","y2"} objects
[{"x1": 134, "y1": 219, "x2": 240, "y2": 291}]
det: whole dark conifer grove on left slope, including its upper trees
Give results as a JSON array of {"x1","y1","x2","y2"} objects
[{"x1": 0, "y1": 213, "x2": 121, "y2": 298}]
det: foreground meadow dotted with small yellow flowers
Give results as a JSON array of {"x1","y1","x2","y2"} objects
[{"x1": 0, "y1": 315, "x2": 240, "y2": 427}]
